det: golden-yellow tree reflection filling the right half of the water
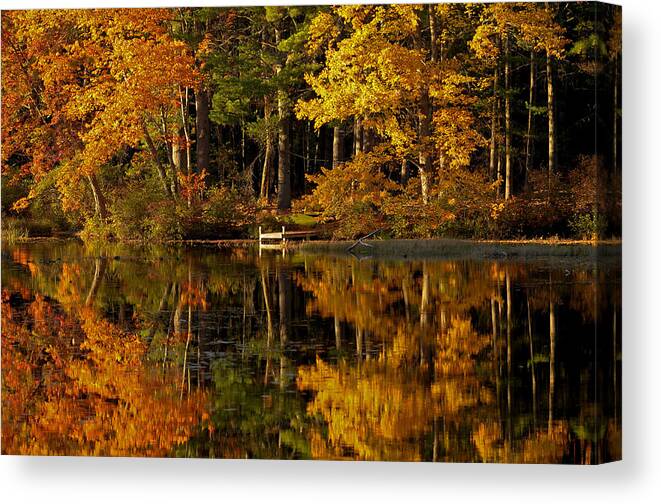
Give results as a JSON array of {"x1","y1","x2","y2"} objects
[{"x1": 297, "y1": 259, "x2": 619, "y2": 463}]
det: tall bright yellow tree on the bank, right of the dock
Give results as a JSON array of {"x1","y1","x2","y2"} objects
[{"x1": 297, "y1": 5, "x2": 475, "y2": 203}]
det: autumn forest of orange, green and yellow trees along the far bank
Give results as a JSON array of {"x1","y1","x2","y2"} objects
[{"x1": 2, "y1": 2, "x2": 622, "y2": 242}]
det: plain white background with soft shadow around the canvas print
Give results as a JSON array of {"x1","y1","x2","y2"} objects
[{"x1": 0, "y1": 0, "x2": 661, "y2": 504}]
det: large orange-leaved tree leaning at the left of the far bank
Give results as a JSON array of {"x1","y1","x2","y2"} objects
[{"x1": 3, "y1": 9, "x2": 197, "y2": 218}]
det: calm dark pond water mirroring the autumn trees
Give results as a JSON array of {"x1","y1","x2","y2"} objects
[{"x1": 2, "y1": 242, "x2": 621, "y2": 464}]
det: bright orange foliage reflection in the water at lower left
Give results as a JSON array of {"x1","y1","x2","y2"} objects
[{"x1": 2, "y1": 296, "x2": 208, "y2": 457}]
